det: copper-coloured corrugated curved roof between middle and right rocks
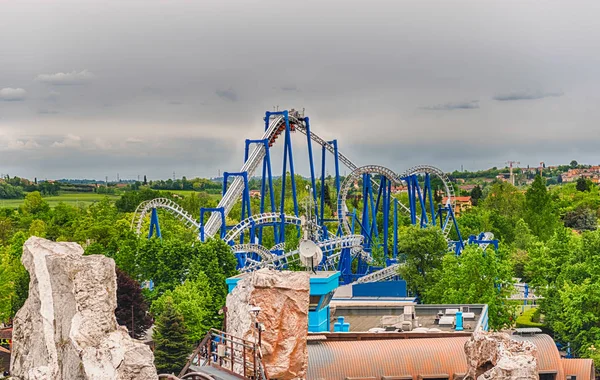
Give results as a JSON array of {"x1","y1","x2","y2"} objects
[{"x1": 308, "y1": 337, "x2": 469, "y2": 380}]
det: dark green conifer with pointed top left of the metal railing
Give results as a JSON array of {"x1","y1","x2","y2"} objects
[{"x1": 153, "y1": 298, "x2": 190, "y2": 373}]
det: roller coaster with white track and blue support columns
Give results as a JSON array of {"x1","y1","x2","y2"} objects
[{"x1": 132, "y1": 109, "x2": 498, "y2": 284}]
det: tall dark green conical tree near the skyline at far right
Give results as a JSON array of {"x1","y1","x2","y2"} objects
[{"x1": 524, "y1": 175, "x2": 558, "y2": 241}]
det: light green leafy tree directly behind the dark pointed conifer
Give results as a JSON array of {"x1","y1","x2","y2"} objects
[{"x1": 151, "y1": 273, "x2": 213, "y2": 342}]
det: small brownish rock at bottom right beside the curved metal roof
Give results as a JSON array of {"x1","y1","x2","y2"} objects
[{"x1": 465, "y1": 331, "x2": 539, "y2": 380}]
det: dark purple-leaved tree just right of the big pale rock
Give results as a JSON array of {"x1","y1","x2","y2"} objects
[{"x1": 115, "y1": 268, "x2": 152, "y2": 339}]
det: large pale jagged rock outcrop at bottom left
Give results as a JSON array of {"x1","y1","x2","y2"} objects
[{"x1": 11, "y1": 237, "x2": 158, "y2": 380}]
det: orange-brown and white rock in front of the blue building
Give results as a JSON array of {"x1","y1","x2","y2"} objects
[{"x1": 227, "y1": 269, "x2": 310, "y2": 380}]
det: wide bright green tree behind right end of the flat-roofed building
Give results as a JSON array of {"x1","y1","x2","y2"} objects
[{"x1": 424, "y1": 245, "x2": 515, "y2": 330}]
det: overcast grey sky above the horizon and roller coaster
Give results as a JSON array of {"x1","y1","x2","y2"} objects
[{"x1": 0, "y1": 0, "x2": 600, "y2": 179}]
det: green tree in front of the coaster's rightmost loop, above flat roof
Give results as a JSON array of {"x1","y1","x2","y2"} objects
[{"x1": 398, "y1": 226, "x2": 448, "y2": 296}]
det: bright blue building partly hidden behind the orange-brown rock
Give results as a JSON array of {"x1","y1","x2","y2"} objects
[{"x1": 225, "y1": 272, "x2": 340, "y2": 332}]
